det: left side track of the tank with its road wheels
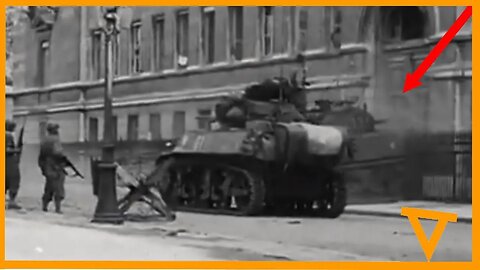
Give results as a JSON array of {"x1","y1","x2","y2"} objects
[{"x1": 156, "y1": 158, "x2": 265, "y2": 216}]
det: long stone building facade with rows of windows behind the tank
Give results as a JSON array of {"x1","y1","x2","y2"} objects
[{"x1": 7, "y1": 6, "x2": 472, "y2": 202}]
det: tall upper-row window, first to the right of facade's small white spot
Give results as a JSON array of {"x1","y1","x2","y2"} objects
[{"x1": 201, "y1": 7, "x2": 215, "y2": 64}]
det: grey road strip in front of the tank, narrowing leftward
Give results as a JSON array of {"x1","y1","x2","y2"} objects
[{"x1": 158, "y1": 213, "x2": 472, "y2": 261}]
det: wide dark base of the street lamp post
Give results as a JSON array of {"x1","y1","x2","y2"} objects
[{"x1": 92, "y1": 161, "x2": 124, "y2": 225}]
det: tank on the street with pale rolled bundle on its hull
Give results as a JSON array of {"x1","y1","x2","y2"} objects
[{"x1": 150, "y1": 69, "x2": 404, "y2": 218}]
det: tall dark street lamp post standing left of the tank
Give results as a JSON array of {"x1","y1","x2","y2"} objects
[{"x1": 92, "y1": 7, "x2": 124, "y2": 224}]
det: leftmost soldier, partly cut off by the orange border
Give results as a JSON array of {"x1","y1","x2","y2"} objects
[{"x1": 5, "y1": 120, "x2": 21, "y2": 209}]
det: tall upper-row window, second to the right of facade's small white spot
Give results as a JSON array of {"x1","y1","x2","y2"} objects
[{"x1": 228, "y1": 7, "x2": 243, "y2": 60}]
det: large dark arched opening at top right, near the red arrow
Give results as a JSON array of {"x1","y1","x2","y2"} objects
[{"x1": 381, "y1": 6, "x2": 427, "y2": 42}]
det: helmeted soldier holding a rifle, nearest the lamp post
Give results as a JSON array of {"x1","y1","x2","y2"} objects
[{"x1": 38, "y1": 123, "x2": 66, "y2": 214}]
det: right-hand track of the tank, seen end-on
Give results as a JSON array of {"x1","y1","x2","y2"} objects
[{"x1": 317, "y1": 172, "x2": 347, "y2": 218}]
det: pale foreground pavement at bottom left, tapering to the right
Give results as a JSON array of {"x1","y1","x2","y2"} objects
[{"x1": 5, "y1": 212, "x2": 378, "y2": 261}]
